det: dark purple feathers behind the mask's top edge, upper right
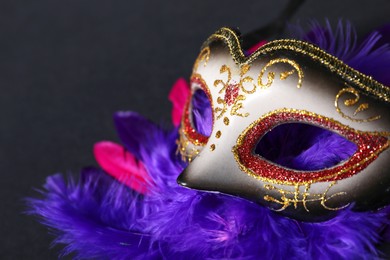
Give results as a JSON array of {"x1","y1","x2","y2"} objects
[{"x1": 290, "y1": 20, "x2": 390, "y2": 85}]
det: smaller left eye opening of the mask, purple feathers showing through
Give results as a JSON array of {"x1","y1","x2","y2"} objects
[{"x1": 190, "y1": 89, "x2": 213, "y2": 137}]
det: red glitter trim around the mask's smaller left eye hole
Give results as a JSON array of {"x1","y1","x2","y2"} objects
[{"x1": 183, "y1": 74, "x2": 214, "y2": 145}]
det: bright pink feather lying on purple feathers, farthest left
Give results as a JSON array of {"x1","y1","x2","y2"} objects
[{"x1": 93, "y1": 141, "x2": 151, "y2": 194}]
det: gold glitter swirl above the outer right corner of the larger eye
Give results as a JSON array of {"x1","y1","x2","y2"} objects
[{"x1": 334, "y1": 87, "x2": 381, "y2": 122}]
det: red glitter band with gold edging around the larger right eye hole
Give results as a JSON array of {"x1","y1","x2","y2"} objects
[{"x1": 233, "y1": 108, "x2": 390, "y2": 185}]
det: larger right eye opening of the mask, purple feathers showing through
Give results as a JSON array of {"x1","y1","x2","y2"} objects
[{"x1": 254, "y1": 123, "x2": 357, "y2": 171}]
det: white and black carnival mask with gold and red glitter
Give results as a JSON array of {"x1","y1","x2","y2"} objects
[{"x1": 178, "y1": 28, "x2": 390, "y2": 221}]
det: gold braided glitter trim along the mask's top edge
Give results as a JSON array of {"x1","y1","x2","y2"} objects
[{"x1": 203, "y1": 27, "x2": 390, "y2": 103}]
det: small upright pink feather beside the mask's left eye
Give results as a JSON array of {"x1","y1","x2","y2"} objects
[{"x1": 169, "y1": 78, "x2": 190, "y2": 126}]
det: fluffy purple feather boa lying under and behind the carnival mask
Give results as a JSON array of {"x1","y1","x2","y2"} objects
[{"x1": 28, "y1": 21, "x2": 390, "y2": 259}]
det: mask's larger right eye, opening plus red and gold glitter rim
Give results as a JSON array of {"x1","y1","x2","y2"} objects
[{"x1": 233, "y1": 108, "x2": 389, "y2": 185}]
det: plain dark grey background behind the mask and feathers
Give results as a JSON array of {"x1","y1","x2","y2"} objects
[{"x1": 0, "y1": 0, "x2": 390, "y2": 259}]
